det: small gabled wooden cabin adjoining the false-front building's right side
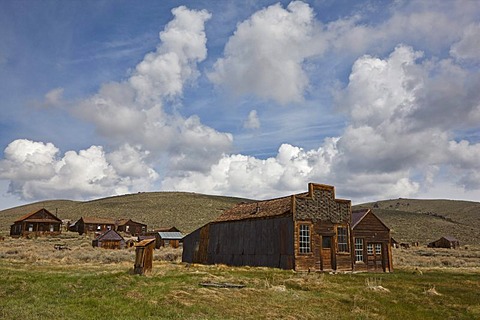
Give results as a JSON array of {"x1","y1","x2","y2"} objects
[{"x1": 352, "y1": 209, "x2": 393, "y2": 272}]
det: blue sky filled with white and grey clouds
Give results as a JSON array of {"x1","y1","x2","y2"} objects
[{"x1": 0, "y1": 0, "x2": 480, "y2": 209}]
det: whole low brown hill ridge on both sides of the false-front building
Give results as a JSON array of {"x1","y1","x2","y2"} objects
[{"x1": 0, "y1": 191, "x2": 480, "y2": 245}]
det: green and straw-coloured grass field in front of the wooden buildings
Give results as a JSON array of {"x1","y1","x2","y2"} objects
[{"x1": 0, "y1": 233, "x2": 480, "y2": 320}]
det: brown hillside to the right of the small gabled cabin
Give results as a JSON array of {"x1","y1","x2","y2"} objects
[{"x1": 354, "y1": 199, "x2": 480, "y2": 245}]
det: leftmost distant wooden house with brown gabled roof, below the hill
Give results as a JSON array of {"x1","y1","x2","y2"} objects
[{"x1": 10, "y1": 209, "x2": 62, "y2": 236}]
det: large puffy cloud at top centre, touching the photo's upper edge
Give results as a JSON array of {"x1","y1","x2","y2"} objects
[{"x1": 209, "y1": 1, "x2": 324, "y2": 104}]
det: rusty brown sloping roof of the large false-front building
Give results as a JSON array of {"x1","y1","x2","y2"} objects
[{"x1": 214, "y1": 196, "x2": 293, "y2": 222}]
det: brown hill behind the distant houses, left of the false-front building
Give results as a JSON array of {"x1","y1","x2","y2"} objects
[{"x1": 0, "y1": 192, "x2": 250, "y2": 233}]
